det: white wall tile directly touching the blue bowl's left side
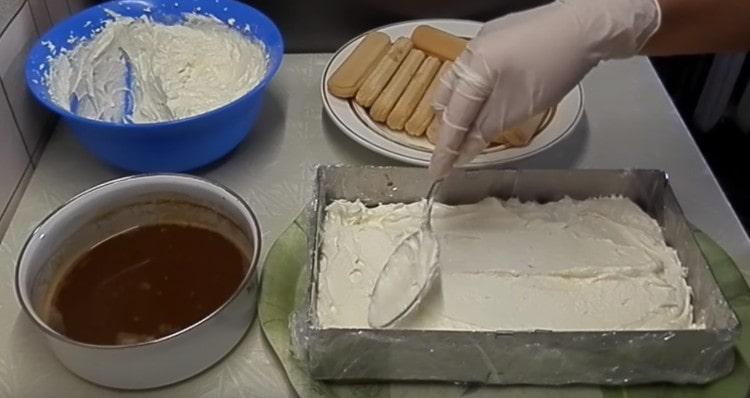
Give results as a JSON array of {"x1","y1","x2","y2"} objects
[{"x1": 0, "y1": 4, "x2": 50, "y2": 153}]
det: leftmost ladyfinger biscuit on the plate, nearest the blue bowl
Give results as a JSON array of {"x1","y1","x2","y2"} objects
[{"x1": 328, "y1": 32, "x2": 391, "y2": 98}]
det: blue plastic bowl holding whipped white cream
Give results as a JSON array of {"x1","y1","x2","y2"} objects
[{"x1": 26, "y1": 0, "x2": 284, "y2": 172}]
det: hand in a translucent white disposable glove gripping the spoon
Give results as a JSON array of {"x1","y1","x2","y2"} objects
[{"x1": 430, "y1": 0, "x2": 661, "y2": 178}]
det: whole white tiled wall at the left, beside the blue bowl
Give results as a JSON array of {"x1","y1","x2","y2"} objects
[{"x1": 0, "y1": 0, "x2": 94, "y2": 237}]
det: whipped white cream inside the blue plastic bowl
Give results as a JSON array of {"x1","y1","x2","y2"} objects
[{"x1": 47, "y1": 14, "x2": 267, "y2": 123}]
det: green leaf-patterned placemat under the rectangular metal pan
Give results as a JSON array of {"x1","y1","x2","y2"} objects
[{"x1": 258, "y1": 216, "x2": 750, "y2": 398}]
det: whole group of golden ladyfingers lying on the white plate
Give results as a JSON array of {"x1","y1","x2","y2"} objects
[{"x1": 328, "y1": 25, "x2": 542, "y2": 147}]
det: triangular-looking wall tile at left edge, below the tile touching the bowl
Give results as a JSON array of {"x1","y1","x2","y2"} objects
[{"x1": 0, "y1": 91, "x2": 30, "y2": 230}]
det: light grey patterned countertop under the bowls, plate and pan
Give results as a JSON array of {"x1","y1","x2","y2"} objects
[{"x1": 0, "y1": 54, "x2": 750, "y2": 398}]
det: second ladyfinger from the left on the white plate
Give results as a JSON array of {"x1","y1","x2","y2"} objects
[{"x1": 355, "y1": 37, "x2": 414, "y2": 108}]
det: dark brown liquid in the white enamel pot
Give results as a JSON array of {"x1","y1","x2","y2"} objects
[{"x1": 52, "y1": 224, "x2": 248, "y2": 345}]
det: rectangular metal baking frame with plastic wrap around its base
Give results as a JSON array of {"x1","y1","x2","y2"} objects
[{"x1": 292, "y1": 166, "x2": 739, "y2": 385}]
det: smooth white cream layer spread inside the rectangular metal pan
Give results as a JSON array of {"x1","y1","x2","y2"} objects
[{"x1": 318, "y1": 198, "x2": 694, "y2": 331}]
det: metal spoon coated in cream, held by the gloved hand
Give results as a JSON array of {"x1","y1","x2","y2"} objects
[{"x1": 367, "y1": 179, "x2": 443, "y2": 328}]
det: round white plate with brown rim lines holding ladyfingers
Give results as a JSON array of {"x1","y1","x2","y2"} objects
[{"x1": 320, "y1": 19, "x2": 583, "y2": 167}]
